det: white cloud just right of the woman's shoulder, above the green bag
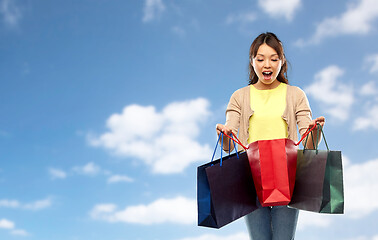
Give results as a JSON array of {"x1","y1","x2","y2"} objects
[{"x1": 305, "y1": 66, "x2": 354, "y2": 121}]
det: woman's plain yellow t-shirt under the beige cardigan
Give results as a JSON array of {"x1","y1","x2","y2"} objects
[{"x1": 248, "y1": 83, "x2": 288, "y2": 143}]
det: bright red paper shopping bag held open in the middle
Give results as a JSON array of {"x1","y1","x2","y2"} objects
[{"x1": 247, "y1": 139, "x2": 298, "y2": 207}]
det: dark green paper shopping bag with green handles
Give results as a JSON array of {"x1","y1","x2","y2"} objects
[{"x1": 289, "y1": 125, "x2": 344, "y2": 214}]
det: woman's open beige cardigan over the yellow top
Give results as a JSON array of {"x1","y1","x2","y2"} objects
[{"x1": 223, "y1": 85, "x2": 312, "y2": 151}]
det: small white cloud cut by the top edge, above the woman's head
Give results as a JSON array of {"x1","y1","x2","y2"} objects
[{"x1": 259, "y1": 0, "x2": 301, "y2": 21}]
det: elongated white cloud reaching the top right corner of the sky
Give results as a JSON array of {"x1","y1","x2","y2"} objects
[{"x1": 298, "y1": 0, "x2": 378, "y2": 46}]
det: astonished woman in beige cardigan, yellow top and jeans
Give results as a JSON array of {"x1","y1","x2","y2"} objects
[{"x1": 216, "y1": 32, "x2": 325, "y2": 240}]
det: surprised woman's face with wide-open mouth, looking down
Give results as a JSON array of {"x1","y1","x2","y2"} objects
[{"x1": 252, "y1": 43, "x2": 282, "y2": 87}]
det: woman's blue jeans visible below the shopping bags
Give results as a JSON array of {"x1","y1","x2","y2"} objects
[{"x1": 245, "y1": 200, "x2": 299, "y2": 240}]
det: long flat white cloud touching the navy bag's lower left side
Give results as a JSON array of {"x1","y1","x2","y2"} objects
[{"x1": 89, "y1": 196, "x2": 197, "y2": 225}]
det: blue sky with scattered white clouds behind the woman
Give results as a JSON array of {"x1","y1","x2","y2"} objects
[{"x1": 0, "y1": 0, "x2": 378, "y2": 240}]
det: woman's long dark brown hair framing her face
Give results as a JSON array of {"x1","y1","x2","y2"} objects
[{"x1": 249, "y1": 32, "x2": 289, "y2": 84}]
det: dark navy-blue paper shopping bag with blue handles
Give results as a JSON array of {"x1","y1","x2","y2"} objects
[{"x1": 197, "y1": 134, "x2": 257, "y2": 228}]
